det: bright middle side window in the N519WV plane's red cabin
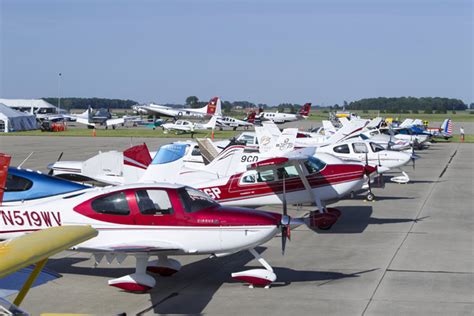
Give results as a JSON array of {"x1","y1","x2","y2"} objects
[{"x1": 135, "y1": 190, "x2": 173, "y2": 215}]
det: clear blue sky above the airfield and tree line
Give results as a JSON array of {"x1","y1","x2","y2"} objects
[{"x1": 0, "y1": 0, "x2": 474, "y2": 105}]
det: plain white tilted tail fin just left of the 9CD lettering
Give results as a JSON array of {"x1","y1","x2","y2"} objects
[{"x1": 205, "y1": 145, "x2": 245, "y2": 177}]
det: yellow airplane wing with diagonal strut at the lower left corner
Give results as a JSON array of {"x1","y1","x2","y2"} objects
[{"x1": 0, "y1": 225, "x2": 98, "y2": 315}]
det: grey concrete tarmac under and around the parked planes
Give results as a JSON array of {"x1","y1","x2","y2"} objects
[{"x1": 0, "y1": 137, "x2": 474, "y2": 315}]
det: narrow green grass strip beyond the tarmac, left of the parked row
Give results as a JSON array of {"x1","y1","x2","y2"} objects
[{"x1": 3, "y1": 128, "x2": 241, "y2": 139}]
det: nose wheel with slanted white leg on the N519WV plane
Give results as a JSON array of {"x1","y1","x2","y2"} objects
[{"x1": 231, "y1": 248, "x2": 276, "y2": 289}]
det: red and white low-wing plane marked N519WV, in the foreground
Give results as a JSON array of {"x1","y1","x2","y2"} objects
[{"x1": 0, "y1": 154, "x2": 331, "y2": 292}]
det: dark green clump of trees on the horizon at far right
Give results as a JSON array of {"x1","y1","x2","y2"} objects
[{"x1": 346, "y1": 97, "x2": 467, "y2": 113}]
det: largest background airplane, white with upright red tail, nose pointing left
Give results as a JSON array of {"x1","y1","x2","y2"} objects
[{"x1": 133, "y1": 97, "x2": 222, "y2": 118}]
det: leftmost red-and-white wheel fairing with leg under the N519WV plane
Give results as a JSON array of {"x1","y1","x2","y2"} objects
[{"x1": 109, "y1": 255, "x2": 156, "y2": 292}]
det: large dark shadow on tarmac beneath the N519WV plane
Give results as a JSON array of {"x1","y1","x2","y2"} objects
[{"x1": 137, "y1": 247, "x2": 377, "y2": 315}]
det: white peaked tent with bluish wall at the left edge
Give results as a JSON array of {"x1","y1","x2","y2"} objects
[{"x1": 0, "y1": 103, "x2": 38, "y2": 133}]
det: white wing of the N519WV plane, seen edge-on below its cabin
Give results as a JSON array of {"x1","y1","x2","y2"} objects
[{"x1": 73, "y1": 240, "x2": 183, "y2": 255}]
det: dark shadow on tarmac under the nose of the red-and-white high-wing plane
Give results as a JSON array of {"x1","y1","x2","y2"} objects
[{"x1": 315, "y1": 206, "x2": 426, "y2": 234}]
